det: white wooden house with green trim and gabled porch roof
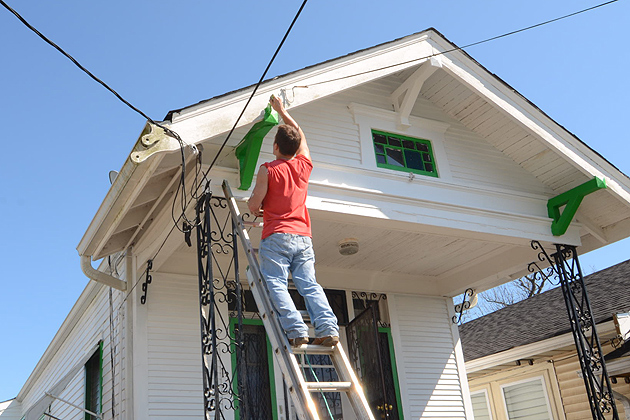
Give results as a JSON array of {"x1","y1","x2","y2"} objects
[{"x1": 0, "y1": 29, "x2": 630, "y2": 420}]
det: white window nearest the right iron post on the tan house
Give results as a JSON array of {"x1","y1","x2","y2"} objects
[{"x1": 503, "y1": 378, "x2": 551, "y2": 420}]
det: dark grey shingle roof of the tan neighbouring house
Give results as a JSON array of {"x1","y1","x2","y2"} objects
[{"x1": 459, "y1": 260, "x2": 630, "y2": 361}]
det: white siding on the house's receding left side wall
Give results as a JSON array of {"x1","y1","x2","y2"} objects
[{"x1": 22, "y1": 285, "x2": 124, "y2": 420}]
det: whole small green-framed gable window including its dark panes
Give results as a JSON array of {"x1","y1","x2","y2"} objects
[{"x1": 372, "y1": 130, "x2": 439, "y2": 178}]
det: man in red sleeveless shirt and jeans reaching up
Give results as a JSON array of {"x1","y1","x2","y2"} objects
[{"x1": 248, "y1": 95, "x2": 339, "y2": 347}]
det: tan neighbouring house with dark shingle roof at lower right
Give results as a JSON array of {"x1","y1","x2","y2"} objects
[{"x1": 459, "y1": 260, "x2": 630, "y2": 420}]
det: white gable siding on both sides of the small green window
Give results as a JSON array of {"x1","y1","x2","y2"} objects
[{"x1": 284, "y1": 78, "x2": 550, "y2": 194}]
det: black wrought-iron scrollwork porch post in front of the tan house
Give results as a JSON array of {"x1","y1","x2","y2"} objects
[{"x1": 528, "y1": 241, "x2": 619, "y2": 420}]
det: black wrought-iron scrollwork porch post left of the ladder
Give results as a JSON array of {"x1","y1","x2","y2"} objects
[{"x1": 196, "y1": 187, "x2": 246, "y2": 420}]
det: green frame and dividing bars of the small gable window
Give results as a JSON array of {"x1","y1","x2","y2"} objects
[{"x1": 372, "y1": 130, "x2": 439, "y2": 178}]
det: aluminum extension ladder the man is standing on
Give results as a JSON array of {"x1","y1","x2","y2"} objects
[{"x1": 223, "y1": 180, "x2": 374, "y2": 420}]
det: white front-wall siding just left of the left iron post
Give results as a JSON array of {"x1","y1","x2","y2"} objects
[{"x1": 147, "y1": 273, "x2": 203, "y2": 419}]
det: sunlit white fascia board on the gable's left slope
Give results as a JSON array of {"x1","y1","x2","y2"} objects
[{"x1": 171, "y1": 32, "x2": 434, "y2": 144}]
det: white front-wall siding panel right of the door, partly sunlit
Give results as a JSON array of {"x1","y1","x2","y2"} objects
[{"x1": 388, "y1": 294, "x2": 466, "y2": 419}]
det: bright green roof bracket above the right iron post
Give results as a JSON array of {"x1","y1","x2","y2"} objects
[{"x1": 547, "y1": 177, "x2": 606, "y2": 236}]
